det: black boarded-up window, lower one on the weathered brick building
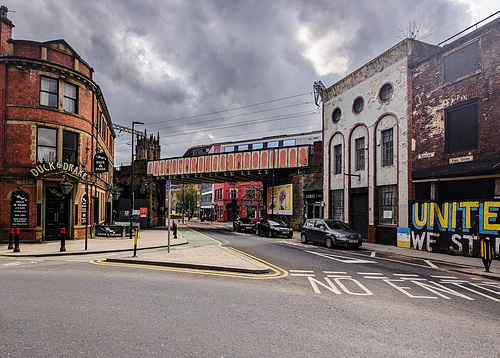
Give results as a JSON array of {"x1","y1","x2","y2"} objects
[{"x1": 445, "y1": 100, "x2": 478, "y2": 153}]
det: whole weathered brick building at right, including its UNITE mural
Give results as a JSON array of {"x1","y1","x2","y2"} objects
[{"x1": 409, "y1": 19, "x2": 500, "y2": 255}]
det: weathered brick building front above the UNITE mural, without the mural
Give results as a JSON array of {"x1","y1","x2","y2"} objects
[{"x1": 411, "y1": 20, "x2": 500, "y2": 200}]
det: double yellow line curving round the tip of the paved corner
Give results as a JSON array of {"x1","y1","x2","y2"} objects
[{"x1": 89, "y1": 246, "x2": 288, "y2": 280}]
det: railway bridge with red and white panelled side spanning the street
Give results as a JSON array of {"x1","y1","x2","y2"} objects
[{"x1": 147, "y1": 142, "x2": 322, "y2": 223}]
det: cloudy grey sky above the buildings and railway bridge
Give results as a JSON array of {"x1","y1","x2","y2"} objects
[{"x1": 2, "y1": 0, "x2": 500, "y2": 166}]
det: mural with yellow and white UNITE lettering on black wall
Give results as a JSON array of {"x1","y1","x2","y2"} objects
[{"x1": 409, "y1": 200, "x2": 500, "y2": 257}]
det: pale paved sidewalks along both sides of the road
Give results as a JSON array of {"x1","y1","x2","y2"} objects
[{"x1": 0, "y1": 220, "x2": 500, "y2": 281}]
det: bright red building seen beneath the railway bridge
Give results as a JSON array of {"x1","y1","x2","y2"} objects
[{"x1": 214, "y1": 182, "x2": 264, "y2": 221}]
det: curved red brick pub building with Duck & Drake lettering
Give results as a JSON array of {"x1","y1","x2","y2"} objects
[{"x1": 0, "y1": 6, "x2": 116, "y2": 242}]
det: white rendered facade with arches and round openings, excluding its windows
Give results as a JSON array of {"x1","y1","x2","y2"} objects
[{"x1": 323, "y1": 41, "x2": 409, "y2": 227}]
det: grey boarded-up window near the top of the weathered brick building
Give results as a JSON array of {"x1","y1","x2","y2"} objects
[{"x1": 444, "y1": 41, "x2": 480, "y2": 83}]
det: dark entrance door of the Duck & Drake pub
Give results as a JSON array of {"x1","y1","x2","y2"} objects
[{"x1": 45, "y1": 187, "x2": 69, "y2": 241}]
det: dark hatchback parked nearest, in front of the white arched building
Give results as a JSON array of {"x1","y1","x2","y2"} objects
[{"x1": 300, "y1": 219, "x2": 363, "y2": 248}]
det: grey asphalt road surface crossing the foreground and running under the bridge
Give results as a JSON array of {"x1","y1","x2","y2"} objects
[{"x1": 0, "y1": 230, "x2": 500, "y2": 357}]
